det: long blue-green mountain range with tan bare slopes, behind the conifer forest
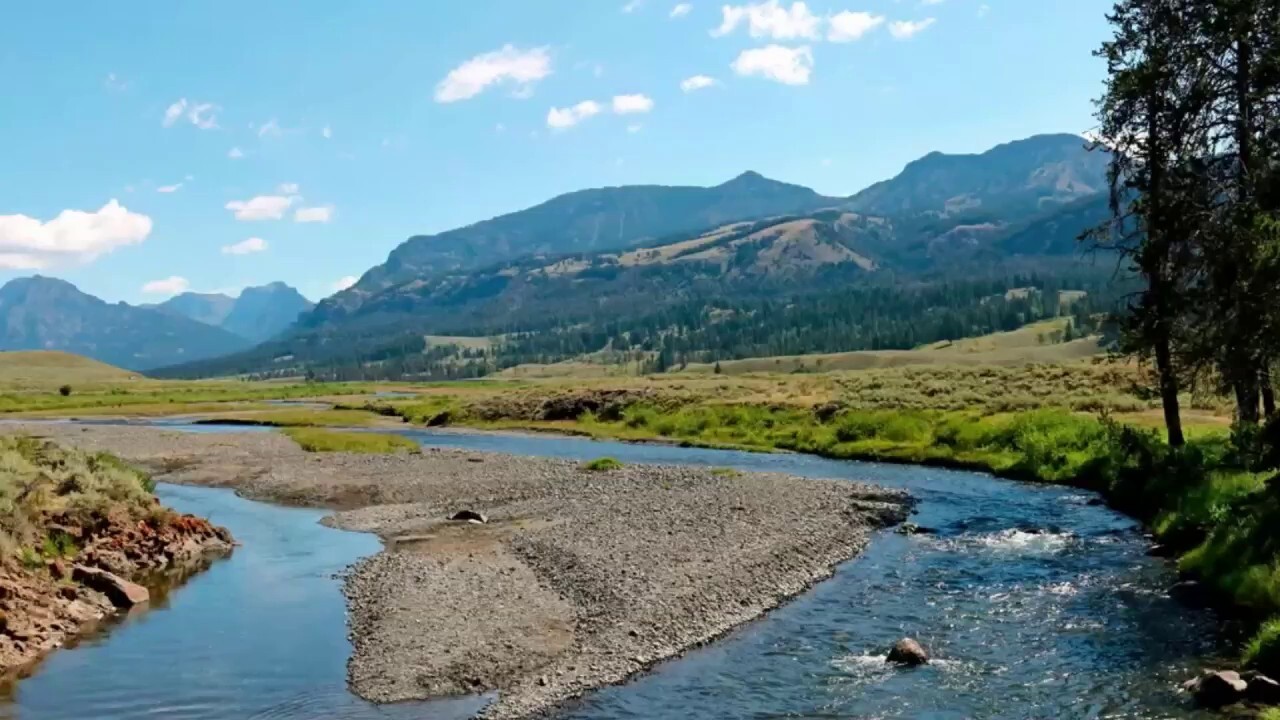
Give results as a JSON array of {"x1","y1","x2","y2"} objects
[{"x1": 6, "y1": 135, "x2": 1108, "y2": 377}]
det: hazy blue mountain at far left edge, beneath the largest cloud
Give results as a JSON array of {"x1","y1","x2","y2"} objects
[{"x1": 0, "y1": 275, "x2": 247, "y2": 370}]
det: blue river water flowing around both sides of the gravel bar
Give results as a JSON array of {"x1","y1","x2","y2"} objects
[{"x1": 0, "y1": 427, "x2": 1225, "y2": 720}]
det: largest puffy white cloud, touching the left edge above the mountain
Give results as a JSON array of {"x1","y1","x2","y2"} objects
[{"x1": 0, "y1": 200, "x2": 151, "y2": 270}]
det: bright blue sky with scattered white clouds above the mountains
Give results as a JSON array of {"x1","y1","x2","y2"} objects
[{"x1": 0, "y1": 0, "x2": 1110, "y2": 302}]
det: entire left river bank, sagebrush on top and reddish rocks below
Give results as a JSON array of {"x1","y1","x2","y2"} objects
[{"x1": 0, "y1": 437, "x2": 233, "y2": 676}]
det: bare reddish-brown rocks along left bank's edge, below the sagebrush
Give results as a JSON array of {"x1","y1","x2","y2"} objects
[{"x1": 0, "y1": 502, "x2": 233, "y2": 676}]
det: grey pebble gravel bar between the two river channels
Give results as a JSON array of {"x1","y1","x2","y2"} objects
[{"x1": 28, "y1": 424, "x2": 910, "y2": 719}]
